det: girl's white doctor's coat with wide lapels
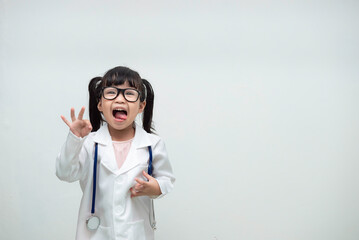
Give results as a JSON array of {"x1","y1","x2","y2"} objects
[{"x1": 56, "y1": 124, "x2": 175, "y2": 240}]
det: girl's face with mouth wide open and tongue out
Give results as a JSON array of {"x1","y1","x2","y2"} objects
[{"x1": 97, "y1": 81, "x2": 146, "y2": 135}]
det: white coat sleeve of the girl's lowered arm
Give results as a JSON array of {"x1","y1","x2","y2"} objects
[{"x1": 152, "y1": 140, "x2": 175, "y2": 198}]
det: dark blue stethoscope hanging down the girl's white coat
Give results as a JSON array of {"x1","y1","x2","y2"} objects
[{"x1": 86, "y1": 143, "x2": 156, "y2": 231}]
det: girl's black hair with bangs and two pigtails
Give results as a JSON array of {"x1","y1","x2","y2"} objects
[{"x1": 88, "y1": 66, "x2": 155, "y2": 133}]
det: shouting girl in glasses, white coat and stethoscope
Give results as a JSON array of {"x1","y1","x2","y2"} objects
[{"x1": 56, "y1": 67, "x2": 175, "y2": 240}]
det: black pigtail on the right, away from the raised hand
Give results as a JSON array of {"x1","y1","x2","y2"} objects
[{"x1": 141, "y1": 79, "x2": 155, "y2": 133}]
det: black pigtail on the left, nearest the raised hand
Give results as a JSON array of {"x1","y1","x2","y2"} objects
[{"x1": 88, "y1": 77, "x2": 102, "y2": 132}]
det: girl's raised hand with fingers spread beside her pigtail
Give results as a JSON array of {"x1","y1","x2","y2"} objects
[{"x1": 61, "y1": 107, "x2": 92, "y2": 137}]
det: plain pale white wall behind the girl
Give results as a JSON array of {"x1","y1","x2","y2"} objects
[{"x1": 0, "y1": 0, "x2": 359, "y2": 240}]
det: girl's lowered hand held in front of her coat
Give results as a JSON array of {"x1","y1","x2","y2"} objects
[{"x1": 130, "y1": 171, "x2": 162, "y2": 198}]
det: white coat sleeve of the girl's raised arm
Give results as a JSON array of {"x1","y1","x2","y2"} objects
[{"x1": 56, "y1": 131, "x2": 86, "y2": 182}]
